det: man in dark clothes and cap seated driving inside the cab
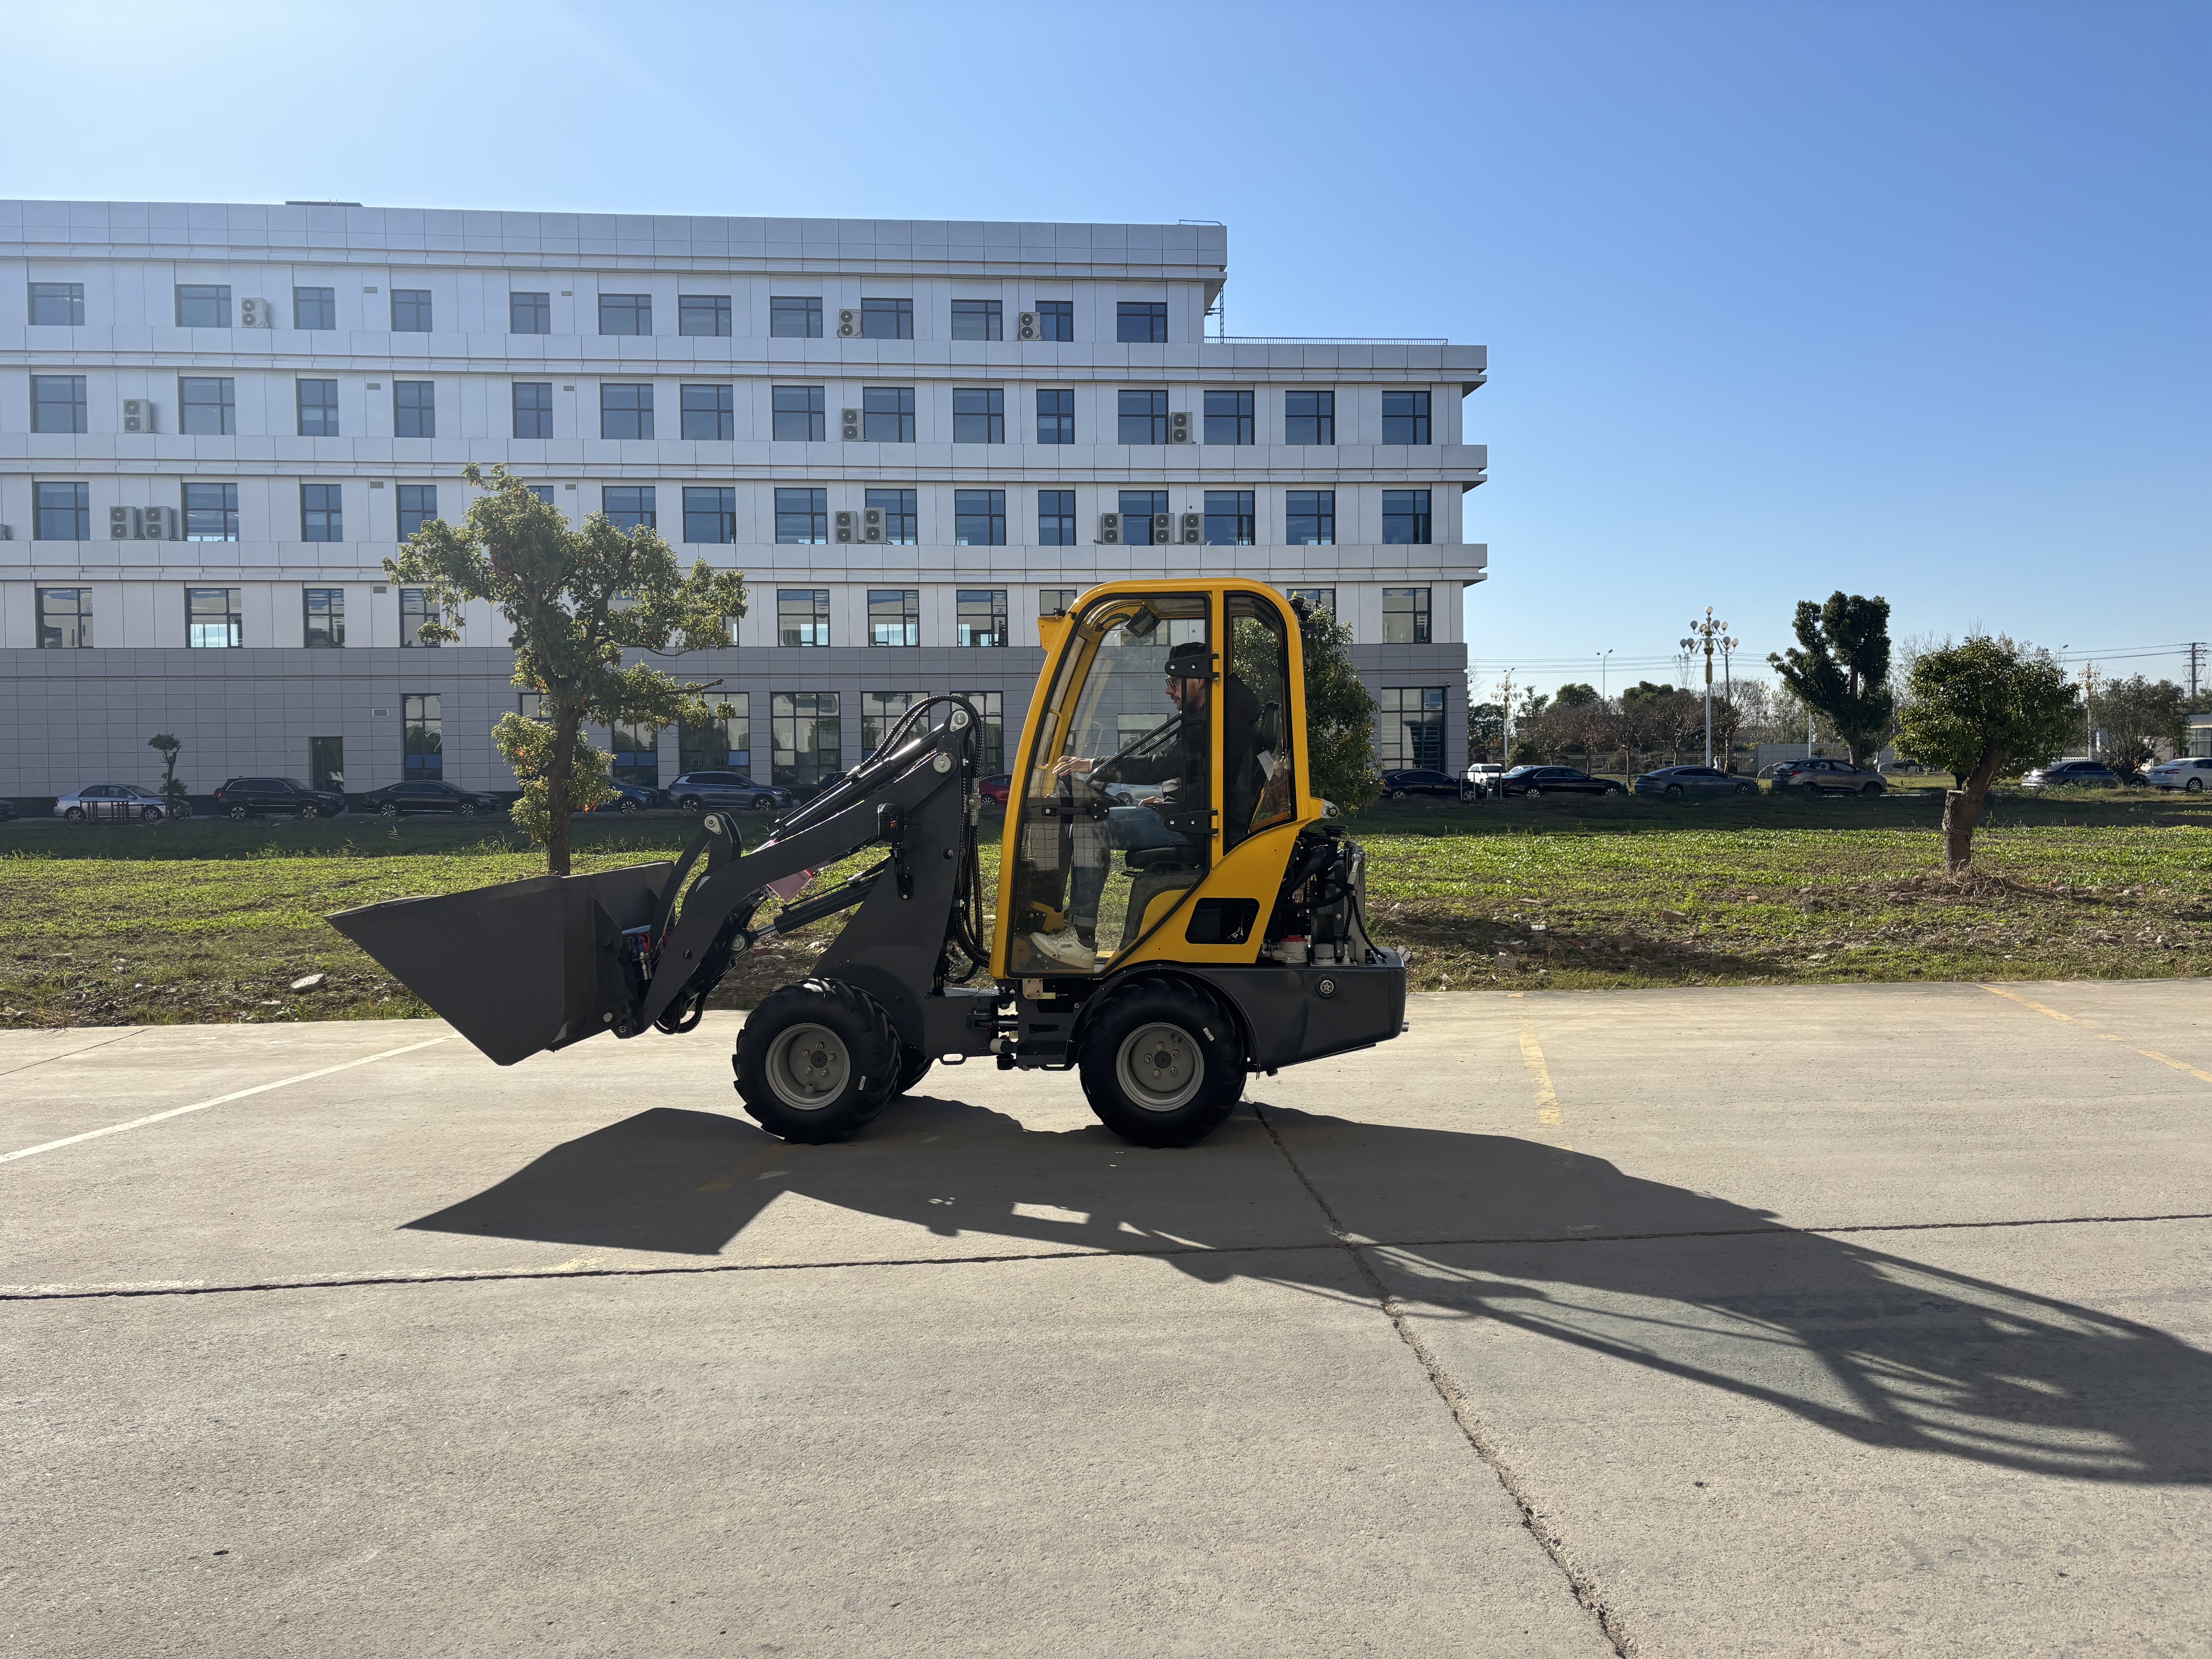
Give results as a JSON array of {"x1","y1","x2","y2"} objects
[{"x1": 1029, "y1": 639, "x2": 1267, "y2": 973}]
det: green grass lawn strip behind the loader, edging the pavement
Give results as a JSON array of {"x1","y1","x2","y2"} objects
[{"x1": 0, "y1": 790, "x2": 2212, "y2": 1026}]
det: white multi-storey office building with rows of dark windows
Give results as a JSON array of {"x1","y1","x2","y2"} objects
[{"x1": 0, "y1": 201, "x2": 1486, "y2": 796}]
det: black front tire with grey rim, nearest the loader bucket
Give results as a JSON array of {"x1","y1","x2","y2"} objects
[{"x1": 730, "y1": 980, "x2": 900, "y2": 1146}]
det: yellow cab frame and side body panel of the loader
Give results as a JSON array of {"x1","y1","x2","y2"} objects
[{"x1": 991, "y1": 577, "x2": 1325, "y2": 980}]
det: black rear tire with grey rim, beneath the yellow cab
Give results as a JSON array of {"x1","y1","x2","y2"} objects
[{"x1": 1079, "y1": 980, "x2": 1245, "y2": 1146}]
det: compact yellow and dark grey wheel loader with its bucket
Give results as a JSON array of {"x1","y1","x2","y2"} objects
[{"x1": 330, "y1": 580, "x2": 1405, "y2": 1146}]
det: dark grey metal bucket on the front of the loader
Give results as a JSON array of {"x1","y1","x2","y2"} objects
[{"x1": 325, "y1": 863, "x2": 675, "y2": 1066}]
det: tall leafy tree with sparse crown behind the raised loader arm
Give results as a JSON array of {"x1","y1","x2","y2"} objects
[{"x1": 385, "y1": 462, "x2": 745, "y2": 876}]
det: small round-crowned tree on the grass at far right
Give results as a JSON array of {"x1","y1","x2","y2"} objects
[{"x1": 1898, "y1": 635, "x2": 2081, "y2": 878}]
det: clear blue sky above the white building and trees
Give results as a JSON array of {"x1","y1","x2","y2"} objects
[{"x1": 0, "y1": 0, "x2": 2212, "y2": 703}]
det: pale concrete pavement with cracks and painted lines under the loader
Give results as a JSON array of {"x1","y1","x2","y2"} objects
[{"x1": 0, "y1": 982, "x2": 2212, "y2": 1655}]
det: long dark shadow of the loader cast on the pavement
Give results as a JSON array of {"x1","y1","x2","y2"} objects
[{"x1": 407, "y1": 1097, "x2": 2212, "y2": 1484}]
